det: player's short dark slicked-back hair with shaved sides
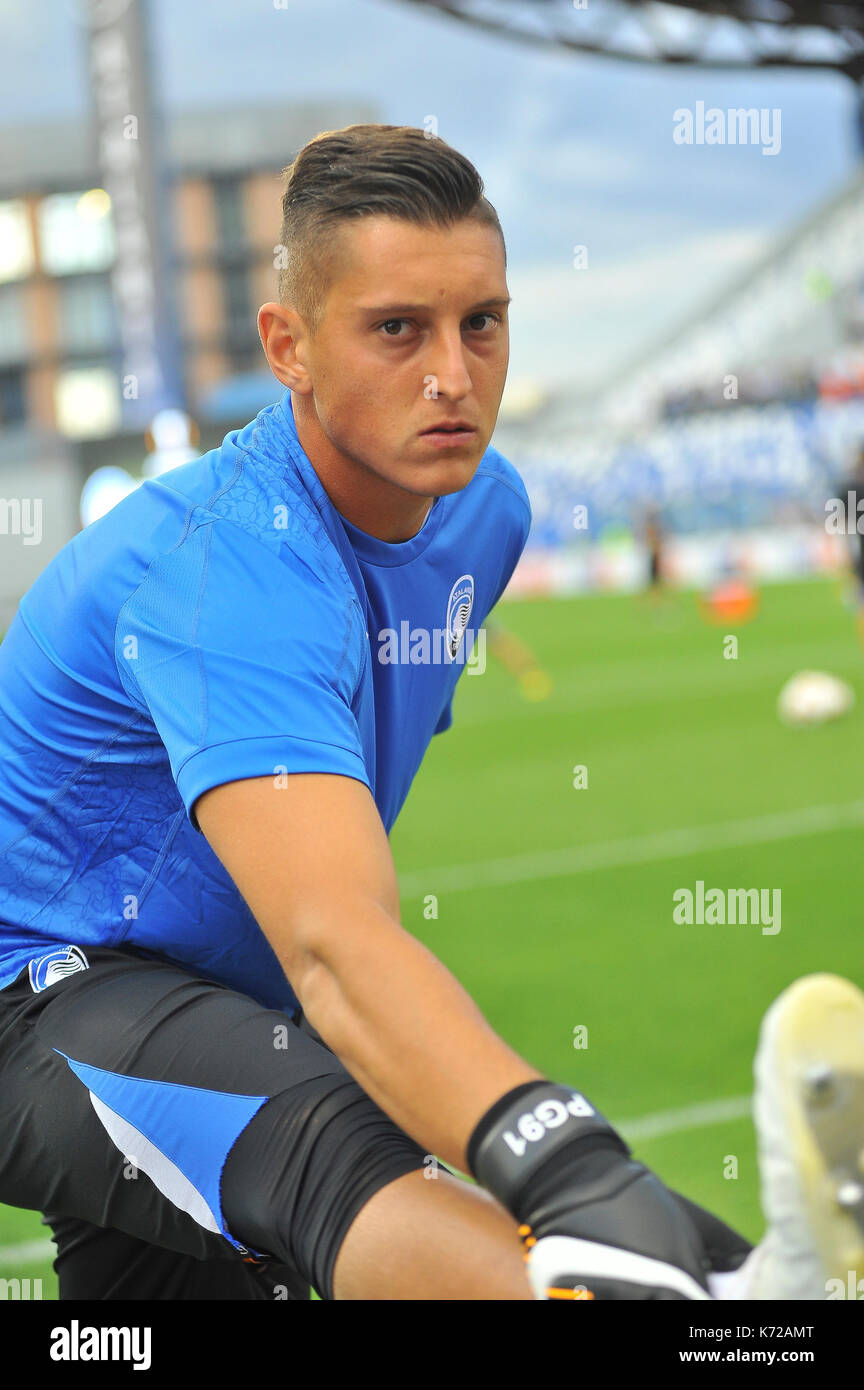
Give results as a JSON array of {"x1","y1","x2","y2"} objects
[{"x1": 279, "y1": 125, "x2": 507, "y2": 334}]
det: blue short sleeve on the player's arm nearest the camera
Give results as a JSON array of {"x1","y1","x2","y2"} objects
[{"x1": 115, "y1": 521, "x2": 369, "y2": 830}]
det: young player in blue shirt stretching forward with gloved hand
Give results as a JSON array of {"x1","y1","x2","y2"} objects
[{"x1": 0, "y1": 125, "x2": 864, "y2": 1300}]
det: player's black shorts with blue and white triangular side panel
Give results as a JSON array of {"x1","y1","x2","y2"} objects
[{"x1": 0, "y1": 948, "x2": 426, "y2": 1300}]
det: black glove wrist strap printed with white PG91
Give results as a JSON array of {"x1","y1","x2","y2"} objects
[{"x1": 467, "y1": 1080, "x2": 631, "y2": 1211}]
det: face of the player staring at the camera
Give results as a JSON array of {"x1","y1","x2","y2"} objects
[{"x1": 273, "y1": 217, "x2": 510, "y2": 498}]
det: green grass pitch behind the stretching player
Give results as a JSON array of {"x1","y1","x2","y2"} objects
[{"x1": 0, "y1": 580, "x2": 864, "y2": 1297}]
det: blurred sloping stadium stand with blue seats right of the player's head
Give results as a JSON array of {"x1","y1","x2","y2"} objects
[{"x1": 493, "y1": 149, "x2": 864, "y2": 589}]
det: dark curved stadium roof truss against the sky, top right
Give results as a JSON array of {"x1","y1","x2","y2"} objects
[{"x1": 404, "y1": 0, "x2": 864, "y2": 82}]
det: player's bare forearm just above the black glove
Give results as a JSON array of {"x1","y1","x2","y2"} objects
[{"x1": 292, "y1": 909, "x2": 542, "y2": 1172}]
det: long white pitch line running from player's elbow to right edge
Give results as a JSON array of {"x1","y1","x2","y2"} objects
[{"x1": 399, "y1": 801, "x2": 864, "y2": 898}]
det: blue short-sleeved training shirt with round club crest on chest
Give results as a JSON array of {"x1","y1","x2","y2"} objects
[{"x1": 0, "y1": 391, "x2": 531, "y2": 1013}]
